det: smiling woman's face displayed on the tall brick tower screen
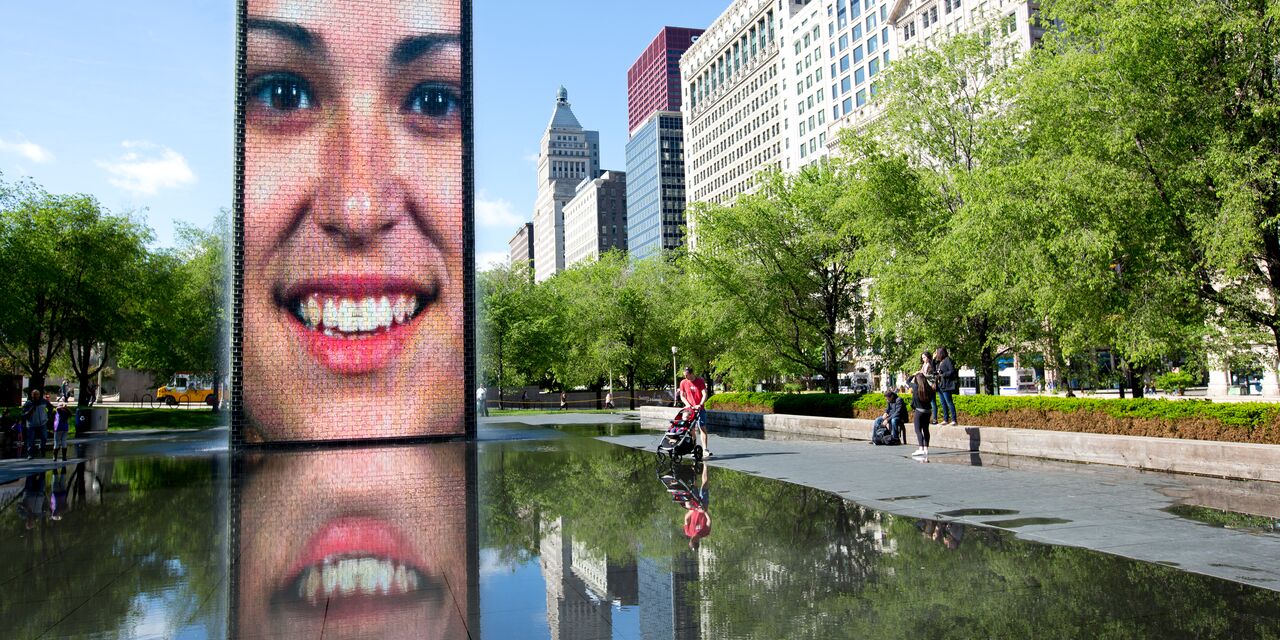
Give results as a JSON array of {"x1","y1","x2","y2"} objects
[{"x1": 242, "y1": 0, "x2": 466, "y2": 442}]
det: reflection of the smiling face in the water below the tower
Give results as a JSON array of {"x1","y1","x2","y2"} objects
[{"x1": 236, "y1": 443, "x2": 468, "y2": 639}]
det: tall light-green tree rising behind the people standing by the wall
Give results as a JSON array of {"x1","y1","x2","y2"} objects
[{"x1": 860, "y1": 28, "x2": 1034, "y2": 393}]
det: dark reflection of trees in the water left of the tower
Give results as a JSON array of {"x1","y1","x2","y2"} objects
[{"x1": 0, "y1": 458, "x2": 225, "y2": 637}]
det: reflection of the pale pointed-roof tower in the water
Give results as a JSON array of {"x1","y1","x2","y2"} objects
[{"x1": 539, "y1": 518, "x2": 613, "y2": 640}]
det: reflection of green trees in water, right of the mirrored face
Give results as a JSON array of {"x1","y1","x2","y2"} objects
[{"x1": 480, "y1": 440, "x2": 1280, "y2": 639}]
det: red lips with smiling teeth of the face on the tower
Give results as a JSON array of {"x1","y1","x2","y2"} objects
[{"x1": 274, "y1": 275, "x2": 438, "y2": 375}]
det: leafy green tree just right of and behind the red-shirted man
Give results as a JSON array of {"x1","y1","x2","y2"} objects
[{"x1": 689, "y1": 163, "x2": 863, "y2": 393}]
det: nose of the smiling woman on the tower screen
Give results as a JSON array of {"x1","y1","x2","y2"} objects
[{"x1": 316, "y1": 97, "x2": 406, "y2": 251}]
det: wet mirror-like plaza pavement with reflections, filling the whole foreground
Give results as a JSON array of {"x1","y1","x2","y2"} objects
[{"x1": 0, "y1": 419, "x2": 1280, "y2": 639}]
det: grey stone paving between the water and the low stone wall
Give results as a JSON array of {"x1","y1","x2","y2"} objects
[{"x1": 599, "y1": 431, "x2": 1280, "y2": 591}]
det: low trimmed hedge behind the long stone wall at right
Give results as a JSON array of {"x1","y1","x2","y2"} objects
[{"x1": 707, "y1": 393, "x2": 1280, "y2": 444}]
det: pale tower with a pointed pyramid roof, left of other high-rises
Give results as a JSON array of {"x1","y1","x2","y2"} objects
[{"x1": 534, "y1": 87, "x2": 600, "y2": 282}]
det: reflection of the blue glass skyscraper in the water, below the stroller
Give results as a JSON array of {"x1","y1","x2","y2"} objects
[{"x1": 636, "y1": 552, "x2": 710, "y2": 640}]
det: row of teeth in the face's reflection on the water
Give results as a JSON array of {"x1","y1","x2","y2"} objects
[{"x1": 298, "y1": 558, "x2": 421, "y2": 604}]
